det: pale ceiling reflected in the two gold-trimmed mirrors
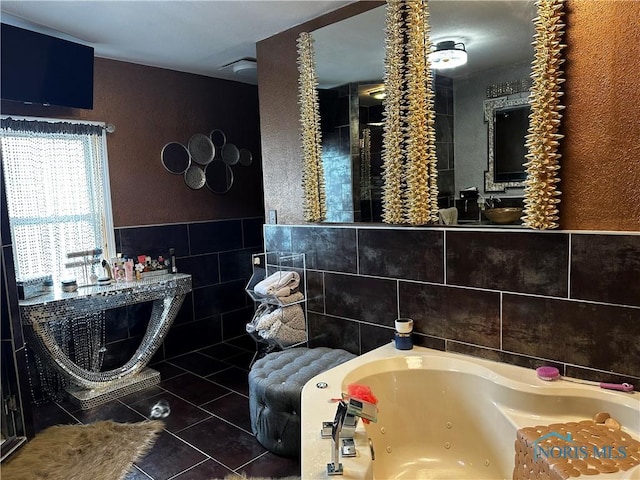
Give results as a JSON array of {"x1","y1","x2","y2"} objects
[{"x1": 313, "y1": 0, "x2": 536, "y2": 88}]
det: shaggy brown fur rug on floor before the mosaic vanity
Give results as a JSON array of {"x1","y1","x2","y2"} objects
[{"x1": 0, "y1": 420, "x2": 164, "y2": 480}]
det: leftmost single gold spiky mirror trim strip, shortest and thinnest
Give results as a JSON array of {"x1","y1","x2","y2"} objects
[{"x1": 297, "y1": 32, "x2": 327, "y2": 222}]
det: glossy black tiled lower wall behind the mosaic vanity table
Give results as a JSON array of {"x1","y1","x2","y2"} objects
[{"x1": 115, "y1": 217, "x2": 264, "y2": 360}]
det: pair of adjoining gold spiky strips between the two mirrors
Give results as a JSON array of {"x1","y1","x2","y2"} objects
[{"x1": 382, "y1": 0, "x2": 438, "y2": 225}]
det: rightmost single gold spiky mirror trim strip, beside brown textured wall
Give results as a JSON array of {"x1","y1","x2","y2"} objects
[{"x1": 522, "y1": 0, "x2": 566, "y2": 230}]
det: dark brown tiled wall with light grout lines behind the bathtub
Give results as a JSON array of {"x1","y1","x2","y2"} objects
[{"x1": 264, "y1": 225, "x2": 640, "y2": 388}]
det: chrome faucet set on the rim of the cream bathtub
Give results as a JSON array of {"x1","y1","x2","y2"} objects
[{"x1": 327, "y1": 398, "x2": 378, "y2": 475}]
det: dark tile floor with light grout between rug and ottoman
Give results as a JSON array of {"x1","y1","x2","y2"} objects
[{"x1": 30, "y1": 342, "x2": 300, "y2": 480}]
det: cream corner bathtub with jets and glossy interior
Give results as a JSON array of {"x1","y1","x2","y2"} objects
[{"x1": 301, "y1": 343, "x2": 640, "y2": 480}]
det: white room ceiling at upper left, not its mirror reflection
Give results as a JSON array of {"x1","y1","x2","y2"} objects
[{"x1": 0, "y1": 0, "x2": 353, "y2": 83}]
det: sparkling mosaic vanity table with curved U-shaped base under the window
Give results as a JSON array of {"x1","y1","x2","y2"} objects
[{"x1": 19, "y1": 273, "x2": 192, "y2": 409}]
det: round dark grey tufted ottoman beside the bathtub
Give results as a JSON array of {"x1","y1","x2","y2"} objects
[{"x1": 249, "y1": 347, "x2": 355, "y2": 457}]
